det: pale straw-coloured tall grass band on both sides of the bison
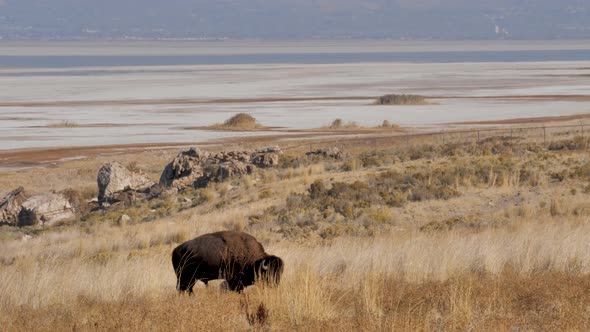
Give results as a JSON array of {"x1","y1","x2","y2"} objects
[{"x1": 0, "y1": 218, "x2": 590, "y2": 327}]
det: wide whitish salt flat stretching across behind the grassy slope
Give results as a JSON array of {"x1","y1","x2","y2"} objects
[{"x1": 0, "y1": 40, "x2": 590, "y2": 150}]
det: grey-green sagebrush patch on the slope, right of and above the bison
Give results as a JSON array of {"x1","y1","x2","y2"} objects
[{"x1": 254, "y1": 172, "x2": 458, "y2": 238}]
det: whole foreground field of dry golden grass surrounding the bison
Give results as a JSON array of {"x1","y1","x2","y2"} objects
[{"x1": 0, "y1": 221, "x2": 590, "y2": 331}]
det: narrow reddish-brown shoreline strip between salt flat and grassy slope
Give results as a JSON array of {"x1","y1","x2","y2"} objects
[{"x1": 0, "y1": 114, "x2": 590, "y2": 173}]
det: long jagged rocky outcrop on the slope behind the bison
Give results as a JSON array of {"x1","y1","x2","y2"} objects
[{"x1": 160, "y1": 147, "x2": 282, "y2": 190}]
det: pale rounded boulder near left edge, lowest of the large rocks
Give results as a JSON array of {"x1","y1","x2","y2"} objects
[{"x1": 18, "y1": 194, "x2": 75, "y2": 226}]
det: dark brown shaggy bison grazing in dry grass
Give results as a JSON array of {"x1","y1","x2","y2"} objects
[{"x1": 172, "y1": 231, "x2": 283, "y2": 294}]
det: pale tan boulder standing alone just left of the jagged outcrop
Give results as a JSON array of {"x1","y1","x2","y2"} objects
[{"x1": 96, "y1": 162, "x2": 154, "y2": 203}]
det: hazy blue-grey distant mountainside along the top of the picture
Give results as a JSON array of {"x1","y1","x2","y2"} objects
[{"x1": 0, "y1": 0, "x2": 590, "y2": 39}]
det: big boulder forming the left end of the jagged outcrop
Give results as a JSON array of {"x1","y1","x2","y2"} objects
[{"x1": 160, "y1": 148, "x2": 209, "y2": 189}]
